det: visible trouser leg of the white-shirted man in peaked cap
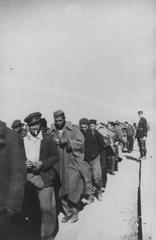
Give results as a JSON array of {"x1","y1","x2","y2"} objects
[{"x1": 39, "y1": 186, "x2": 58, "y2": 240}]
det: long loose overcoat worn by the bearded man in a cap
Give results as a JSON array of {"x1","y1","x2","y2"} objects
[{"x1": 50, "y1": 122, "x2": 85, "y2": 203}]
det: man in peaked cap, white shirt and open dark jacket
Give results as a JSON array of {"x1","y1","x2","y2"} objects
[{"x1": 24, "y1": 112, "x2": 58, "y2": 240}]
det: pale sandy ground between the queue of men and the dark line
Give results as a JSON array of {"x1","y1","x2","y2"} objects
[{"x1": 56, "y1": 147, "x2": 139, "y2": 240}]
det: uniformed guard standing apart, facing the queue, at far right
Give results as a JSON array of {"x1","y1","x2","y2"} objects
[{"x1": 135, "y1": 111, "x2": 148, "y2": 160}]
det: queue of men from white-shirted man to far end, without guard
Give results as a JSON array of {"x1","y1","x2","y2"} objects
[{"x1": 0, "y1": 110, "x2": 147, "y2": 240}]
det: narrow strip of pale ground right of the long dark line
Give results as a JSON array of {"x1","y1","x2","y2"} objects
[{"x1": 141, "y1": 135, "x2": 156, "y2": 240}]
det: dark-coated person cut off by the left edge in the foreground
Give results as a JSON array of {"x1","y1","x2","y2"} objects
[{"x1": 0, "y1": 121, "x2": 26, "y2": 239}]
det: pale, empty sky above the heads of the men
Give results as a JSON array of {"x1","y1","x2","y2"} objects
[{"x1": 0, "y1": 0, "x2": 156, "y2": 125}]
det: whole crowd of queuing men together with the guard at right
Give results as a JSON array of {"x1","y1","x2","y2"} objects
[{"x1": 0, "y1": 110, "x2": 148, "y2": 240}]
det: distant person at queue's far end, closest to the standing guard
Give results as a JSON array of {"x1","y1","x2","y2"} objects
[{"x1": 125, "y1": 122, "x2": 135, "y2": 153}]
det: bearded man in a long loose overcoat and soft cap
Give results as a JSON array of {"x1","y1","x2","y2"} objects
[{"x1": 50, "y1": 110, "x2": 85, "y2": 223}]
